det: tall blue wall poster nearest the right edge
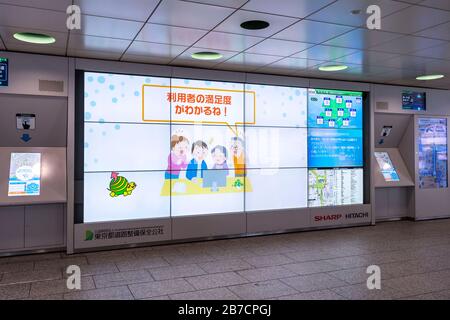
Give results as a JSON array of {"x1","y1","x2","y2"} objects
[{"x1": 418, "y1": 118, "x2": 447, "y2": 188}]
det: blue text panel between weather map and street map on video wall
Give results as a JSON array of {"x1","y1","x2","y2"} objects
[{"x1": 308, "y1": 129, "x2": 363, "y2": 168}]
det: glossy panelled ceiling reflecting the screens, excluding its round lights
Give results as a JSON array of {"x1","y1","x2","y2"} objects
[{"x1": 0, "y1": 0, "x2": 450, "y2": 89}]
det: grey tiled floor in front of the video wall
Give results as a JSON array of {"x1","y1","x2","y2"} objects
[{"x1": 0, "y1": 220, "x2": 450, "y2": 299}]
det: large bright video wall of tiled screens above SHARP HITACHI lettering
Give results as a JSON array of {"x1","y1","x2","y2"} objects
[{"x1": 79, "y1": 72, "x2": 364, "y2": 222}]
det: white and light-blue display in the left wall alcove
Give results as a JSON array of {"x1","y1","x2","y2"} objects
[{"x1": 8, "y1": 153, "x2": 41, "y2": 197}]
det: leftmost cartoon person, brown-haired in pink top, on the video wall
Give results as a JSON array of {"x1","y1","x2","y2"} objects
[{"x1": 165, "y1": 134, "x2": 189, "y2": 179}]
